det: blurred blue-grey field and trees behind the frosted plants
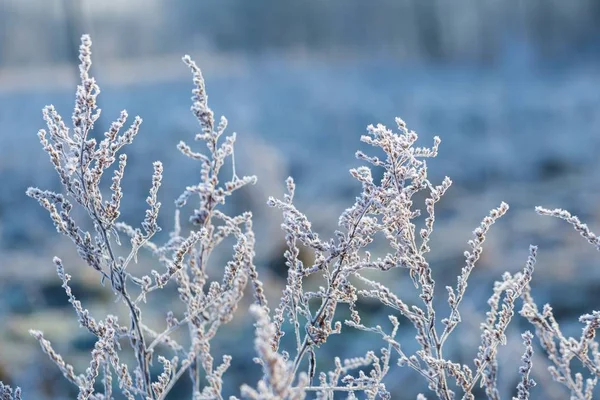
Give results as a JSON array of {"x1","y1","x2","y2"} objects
[{"x1": 0, "y1": 0, "x2": 600, "y2": 399}]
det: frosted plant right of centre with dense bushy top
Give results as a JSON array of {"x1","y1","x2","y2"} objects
[{"x1": 260, "y1": 110, "x2": 536, "y2": 399}]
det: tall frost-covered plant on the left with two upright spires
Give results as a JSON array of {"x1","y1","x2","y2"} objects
[{"x1": 27, "y1": 36, "x2": 266, "y2": 399}]
